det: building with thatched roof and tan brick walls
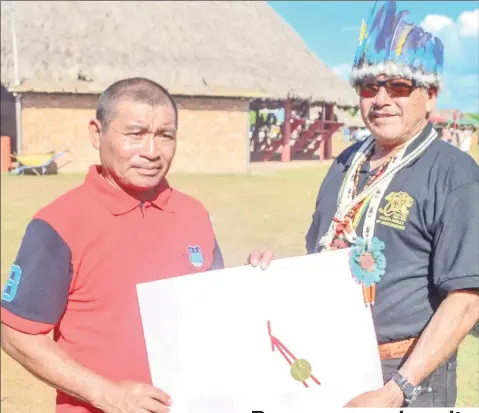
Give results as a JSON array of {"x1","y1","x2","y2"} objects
[{"x1": 1, "y1": 1, "x2": 357, "y2": 172}]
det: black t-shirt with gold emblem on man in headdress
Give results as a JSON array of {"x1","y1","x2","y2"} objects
[{"x1": 306, "y1": 125, "x2": 479, "y2": 343}]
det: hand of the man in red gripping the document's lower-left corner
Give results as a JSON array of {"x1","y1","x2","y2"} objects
[{"x1": 94, "y1": 381, "x2": 171, "y2": 413}]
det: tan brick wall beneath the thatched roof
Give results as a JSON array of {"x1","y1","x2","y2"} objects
[{"x1": 18, "y1": 93, "x2": 249, "y2": 173}]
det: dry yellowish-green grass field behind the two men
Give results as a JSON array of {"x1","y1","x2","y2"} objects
[{"x1": 1, "y1": 144, "x2": 479, "y2": 413}]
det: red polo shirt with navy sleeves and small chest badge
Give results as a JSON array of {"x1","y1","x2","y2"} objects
[{"x1": 2, "y1": 166, "x2": 223, "y2": 413}]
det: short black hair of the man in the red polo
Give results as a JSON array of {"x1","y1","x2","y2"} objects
[{"x1": 96, "y1": 77, "x2": 178, "y2": 130}]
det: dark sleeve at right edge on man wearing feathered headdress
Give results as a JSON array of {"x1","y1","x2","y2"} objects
[{"x1": 432, "y1": 181, "x2": 479, "y2": 297}]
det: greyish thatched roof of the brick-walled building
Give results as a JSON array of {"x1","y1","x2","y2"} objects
[{"x1": 1, "y1": 1, "x2": 358, "y2": 106}]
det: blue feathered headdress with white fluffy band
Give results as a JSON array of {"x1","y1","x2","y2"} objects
[{"x1": 350, "y1": 0, "x2": 444, "y2": 88}]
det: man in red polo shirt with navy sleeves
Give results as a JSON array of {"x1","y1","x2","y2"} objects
[{"x1": 1, "y1": 78, "x2": 223, "y2": 413}]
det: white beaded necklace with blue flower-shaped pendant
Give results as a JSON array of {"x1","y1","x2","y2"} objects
[{"x1": 319, "y1": 129, "x2": 437, "y2": 305}]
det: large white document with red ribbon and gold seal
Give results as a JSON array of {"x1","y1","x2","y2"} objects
[{"x1": 137, "y1": 250, "x2": 383, "y2": 413}]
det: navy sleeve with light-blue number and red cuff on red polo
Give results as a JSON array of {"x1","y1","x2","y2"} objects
[{"x1": 1, "y1": 219, "x2": 72, "y2": 334}]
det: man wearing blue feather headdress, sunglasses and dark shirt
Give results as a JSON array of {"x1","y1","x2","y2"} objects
[{"x1": 249, "y1": 1, "x2": 479, "y2": 407}]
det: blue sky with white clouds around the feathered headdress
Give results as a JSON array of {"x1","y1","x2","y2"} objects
[{"x1": 268, "y1": 1, "x2": 479, "y2": 113}]
